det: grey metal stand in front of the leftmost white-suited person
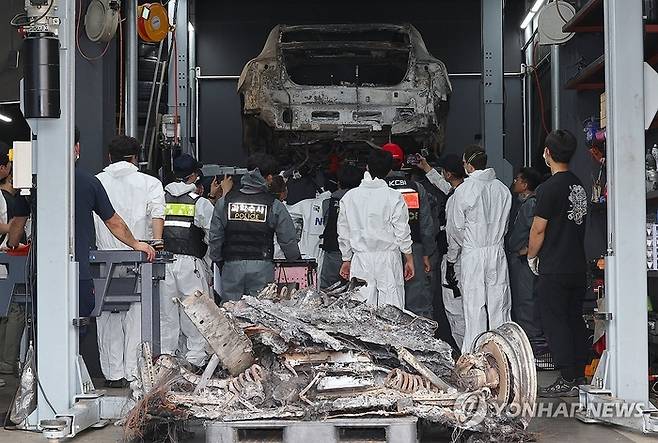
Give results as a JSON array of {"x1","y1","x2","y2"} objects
[{"x1": 89, "y1": 250, "x2": 173, "y2": 355}]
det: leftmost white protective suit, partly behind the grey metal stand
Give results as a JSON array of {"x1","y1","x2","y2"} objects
[{"x1": 94, "y1": 161, "x2": 165, "y2": 381}]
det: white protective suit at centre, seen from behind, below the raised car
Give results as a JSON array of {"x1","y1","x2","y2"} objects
[{"x1": 337, "y1": 172, "x2": 412, "y2": 309}]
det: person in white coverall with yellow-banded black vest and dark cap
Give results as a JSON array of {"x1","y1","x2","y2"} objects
[{"x1": 160, "y1": 154, "x2": 215, "y2": 366}]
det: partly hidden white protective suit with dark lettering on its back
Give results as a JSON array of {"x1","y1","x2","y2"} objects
[{"x1": 286, "y1": 191, "x2": 331, "y2": 269}]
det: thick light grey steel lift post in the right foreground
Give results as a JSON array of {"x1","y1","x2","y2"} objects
[{"x1": 604, "y1": 0, "x2": 649, "y2": 404}]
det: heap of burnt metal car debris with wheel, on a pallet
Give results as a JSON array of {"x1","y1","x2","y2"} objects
[{"x1": 125, "y1": 284, "x2": 537, "y2": 441}]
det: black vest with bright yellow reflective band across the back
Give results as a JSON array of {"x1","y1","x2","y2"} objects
[{"x1": 162, "y1": 192, "x2": 208, "y2": 258}]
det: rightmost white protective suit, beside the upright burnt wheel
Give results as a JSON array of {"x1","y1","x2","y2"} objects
[{"x1": 446, "y1": 168, "x2": 512, "y2": 352}]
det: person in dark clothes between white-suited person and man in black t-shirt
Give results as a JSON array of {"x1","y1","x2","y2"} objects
[{"x1": 507, "y1": 168, "x2": 546, "y2": 351}]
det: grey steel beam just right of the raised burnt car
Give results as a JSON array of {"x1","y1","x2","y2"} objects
[{"x1": 481, "y1": 0, "x2": 513, "y2": 184}]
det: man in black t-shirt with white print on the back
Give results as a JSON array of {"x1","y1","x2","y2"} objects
[{"x1": 528, "y1": 130, "x2": 587, "y2": 397}]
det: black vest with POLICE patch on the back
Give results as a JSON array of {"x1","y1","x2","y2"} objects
[{"x1": 222, "y1": 191, "x2": 274, "y2": 261}]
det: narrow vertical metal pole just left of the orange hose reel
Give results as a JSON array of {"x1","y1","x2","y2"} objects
[{"x1": 124, "y1": 0, "x2": 138, "y2": 138}]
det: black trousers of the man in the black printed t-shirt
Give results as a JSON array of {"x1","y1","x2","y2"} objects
[{"x1": 537, "y1": 274, "x2": 588, "y2": 380}]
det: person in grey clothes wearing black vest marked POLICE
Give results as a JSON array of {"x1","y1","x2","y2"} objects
[{"x1": 209, "y1": 154, "x2": 301, "y2": 301}]
